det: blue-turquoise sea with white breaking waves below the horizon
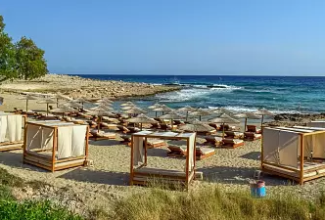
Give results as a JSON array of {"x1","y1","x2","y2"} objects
[{"x1": 70, "y1": 74, "x2": 325, "y2": 114}]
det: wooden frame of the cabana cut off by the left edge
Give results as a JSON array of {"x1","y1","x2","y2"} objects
[{"x1": 0, "y1": 113, "x2": 27, "y2": 152}]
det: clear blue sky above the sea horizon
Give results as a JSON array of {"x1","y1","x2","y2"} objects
[{"x1": 0, "y1": 0, "x2": 325, "y2": 76}]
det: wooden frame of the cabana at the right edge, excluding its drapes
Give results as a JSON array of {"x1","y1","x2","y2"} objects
[{"x1": 261, "y1": 127, "x2": 325, "y2": 185}]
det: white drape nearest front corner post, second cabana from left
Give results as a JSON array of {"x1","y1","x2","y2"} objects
[{"x1": 58, "y1": 126, "x2": 72, "y2": 159}]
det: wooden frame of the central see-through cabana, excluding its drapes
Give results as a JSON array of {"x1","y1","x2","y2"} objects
[{"x1": 130, "y1": 132, "x2": 196, "y2": 189}]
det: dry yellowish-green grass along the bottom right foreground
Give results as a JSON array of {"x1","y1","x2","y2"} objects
[{"x1": 110, "y1": 187, "x2": 325, "y2": 220}]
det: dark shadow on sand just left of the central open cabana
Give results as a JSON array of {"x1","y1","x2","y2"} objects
[{"x1": 58, "y1": 168, "x2": 130, "y2": 186}]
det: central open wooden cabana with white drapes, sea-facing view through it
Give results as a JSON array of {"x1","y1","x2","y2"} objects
[{"x1": 130, "y1": 131, "x2": 196, "y2": 188}]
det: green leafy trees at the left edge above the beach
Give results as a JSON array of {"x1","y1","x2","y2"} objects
[{"x1": 0, "y1": 15, "x2": 48, "y2": 82}]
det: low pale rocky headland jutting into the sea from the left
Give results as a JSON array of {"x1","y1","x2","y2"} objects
[{"x1": 0, "y1": 74, "x2": 181, "y2": 99}]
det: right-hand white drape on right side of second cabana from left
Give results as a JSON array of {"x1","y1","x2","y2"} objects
[{"x1": 72, "y1": 125, "x2": 87, "y2": 157}]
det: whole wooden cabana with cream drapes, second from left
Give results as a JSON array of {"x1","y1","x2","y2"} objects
[{"x1": 23, "y1": 121, "x2": 89, "y2": 172}]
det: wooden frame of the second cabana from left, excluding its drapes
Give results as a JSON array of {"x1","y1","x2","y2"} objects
[{"x1": 23, "y1": 122, "x2": 89, "y2": 172}]
